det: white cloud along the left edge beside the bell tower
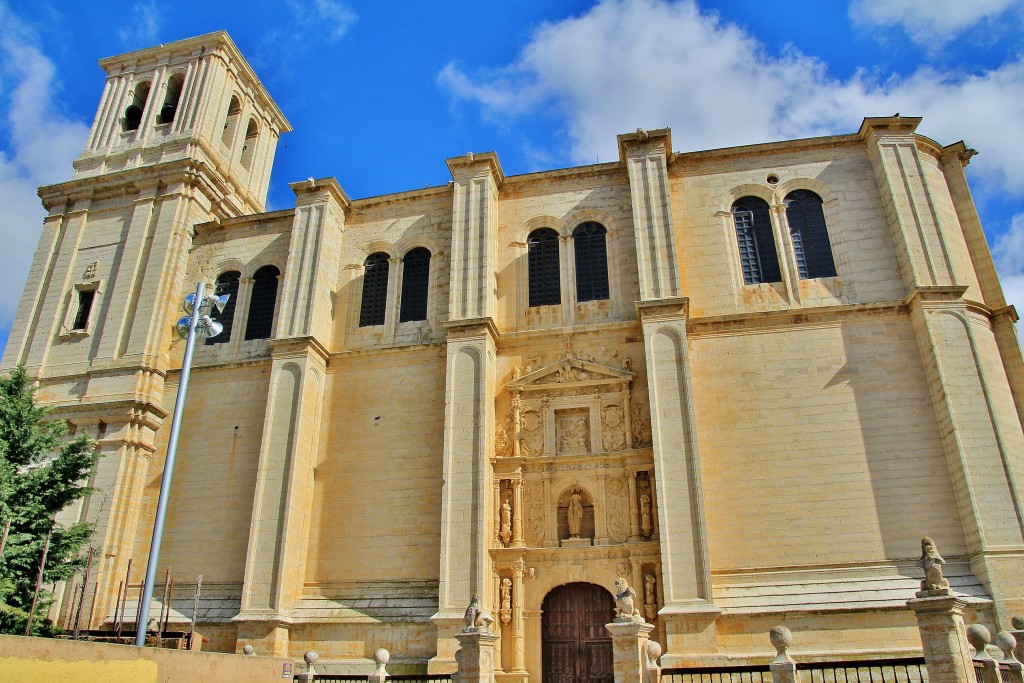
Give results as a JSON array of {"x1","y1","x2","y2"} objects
[{"x1": 0, "y1": 4, "x2": 88, "y2": 330}]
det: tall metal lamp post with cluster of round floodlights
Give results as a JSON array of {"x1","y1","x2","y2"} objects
[{"x1": 135, "y1": 283, "x2": 227, "y2": 647}]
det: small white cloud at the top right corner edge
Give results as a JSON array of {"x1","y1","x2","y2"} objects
[{"x1": 850, "y1": 0, "x2": 1022, "y2": 50}]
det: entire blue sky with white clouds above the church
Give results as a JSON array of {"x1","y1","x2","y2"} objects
[{"x1": 0, "y1": 0, "x2": 1024, "y2": 352}]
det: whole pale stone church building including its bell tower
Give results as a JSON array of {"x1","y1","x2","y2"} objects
[{"x1": 3, "y1": 33, "x2": 1024, "y2": 681}]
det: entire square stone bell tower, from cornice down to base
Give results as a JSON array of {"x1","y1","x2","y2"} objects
[{"x1": 0, "y1": 32, "x2": 291, "y2": 627}]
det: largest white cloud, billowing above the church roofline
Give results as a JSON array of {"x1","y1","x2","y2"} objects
[{"x1": 438, "y1": 0, "x2": 1024, "y2": 193}]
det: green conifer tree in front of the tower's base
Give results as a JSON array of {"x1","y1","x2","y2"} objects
[{"x1": 0, "y1": 367, "x2": 99, "y2": 635}]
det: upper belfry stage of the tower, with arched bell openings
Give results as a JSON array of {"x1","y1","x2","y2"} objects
[{"x1": 75, "y1": 31, "x2": 291, "y2": 217}]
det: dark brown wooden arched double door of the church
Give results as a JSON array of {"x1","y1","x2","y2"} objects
[{"x1": 541, "y1": 584, "x2": 615, "y2": 683}]
